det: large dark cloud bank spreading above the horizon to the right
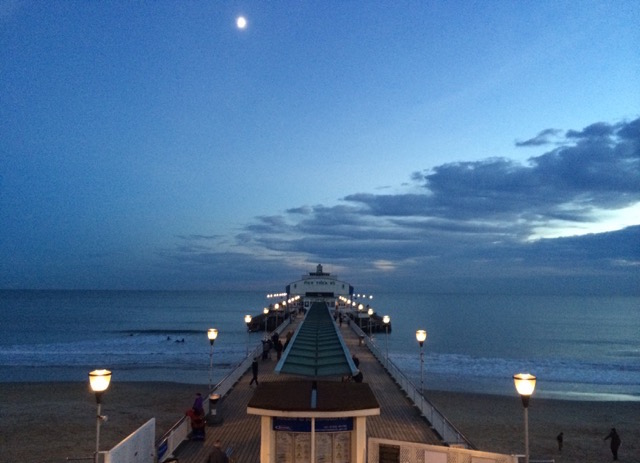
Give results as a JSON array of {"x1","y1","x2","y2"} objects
[{"x1": 166, "y1": 119, "x2": 640, "y2": 293}]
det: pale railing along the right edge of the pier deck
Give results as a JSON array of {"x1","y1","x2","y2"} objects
[{"x1": 350, "y1": 323, "x2": 475, "y2": 449}]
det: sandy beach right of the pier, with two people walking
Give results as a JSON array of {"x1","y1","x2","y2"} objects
[{"x1": 428, "y1": 392, "x2": 640, "y2": 463}]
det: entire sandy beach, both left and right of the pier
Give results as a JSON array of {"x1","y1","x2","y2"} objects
[{"x1": 0, "y1": 383, "x2": 640, "y2": 463}]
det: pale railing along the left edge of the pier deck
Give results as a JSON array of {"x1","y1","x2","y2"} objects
[{"x1": 156, "y1": 317, "x2": 291, "y2": 463}]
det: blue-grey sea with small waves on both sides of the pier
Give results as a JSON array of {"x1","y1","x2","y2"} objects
[{"x1": 0, "y1": 290, "x2": 640, "y2": 401}]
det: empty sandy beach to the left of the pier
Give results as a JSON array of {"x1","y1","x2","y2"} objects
[{"x1": 0, "y1": 381, "x2": 192, "y2": 463}]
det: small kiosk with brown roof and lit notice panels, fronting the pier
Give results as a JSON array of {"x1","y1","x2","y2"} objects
[{"x1": 247, "y1": 380, "x2": 380, "y2": 463}]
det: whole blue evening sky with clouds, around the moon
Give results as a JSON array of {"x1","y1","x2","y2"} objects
[{"x1": 0, "y1": 0, "x2": 640, "y2": 295}]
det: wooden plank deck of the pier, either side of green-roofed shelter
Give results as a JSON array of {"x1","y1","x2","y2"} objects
[{"x1": 175, "y1": 324, "x2": 442, "y2": 463}]
